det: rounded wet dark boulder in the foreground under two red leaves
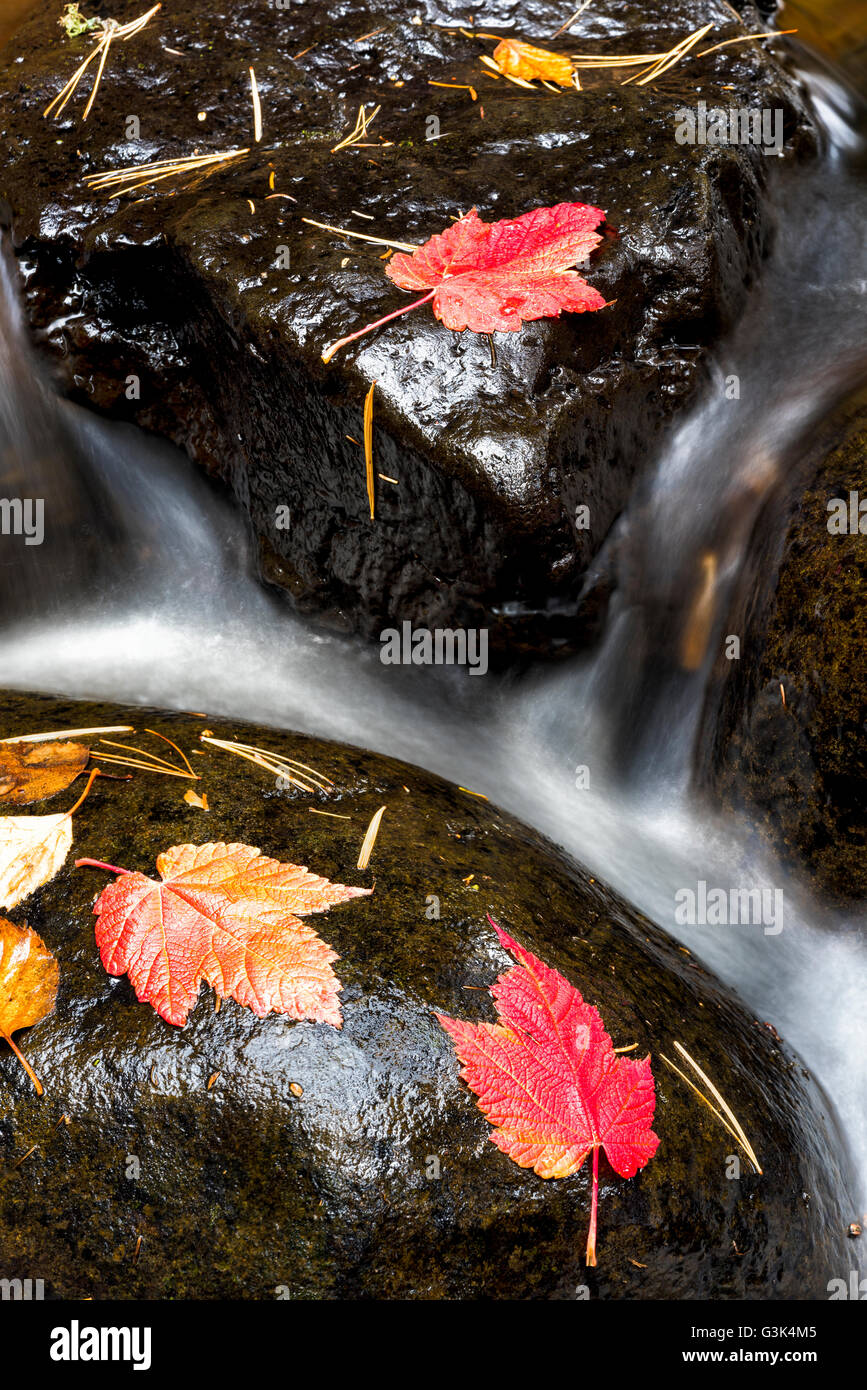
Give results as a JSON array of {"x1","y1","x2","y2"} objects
[{"x1": 0, "y1": 695, "x2": 859, "y2": 1298}]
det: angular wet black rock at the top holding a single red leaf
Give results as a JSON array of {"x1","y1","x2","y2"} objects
[{"x1": 0, "y1": 0, "x2": 814, "y2": 652}]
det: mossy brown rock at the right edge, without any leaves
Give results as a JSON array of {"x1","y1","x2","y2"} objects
[{"x1": 699, "y1": 395, "x2": 867, "y2": 905}]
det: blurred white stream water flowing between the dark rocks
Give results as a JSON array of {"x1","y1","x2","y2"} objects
[{"x1": 0, "y1": 60, "x2": 867, "y2": 1206}]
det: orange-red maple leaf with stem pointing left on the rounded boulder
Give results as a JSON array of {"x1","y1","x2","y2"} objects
[{"x1": 76, "y1": 844, "x2": 372, "y2": 1029}]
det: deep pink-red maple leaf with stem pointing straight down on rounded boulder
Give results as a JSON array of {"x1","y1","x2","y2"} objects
[{"x1": 436, "y1": 917, "x2": 659, "y2": 1265}]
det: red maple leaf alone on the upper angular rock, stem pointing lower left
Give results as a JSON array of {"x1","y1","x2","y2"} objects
[{"x1": 322, "y1": 203, "x2": 606, "y2": 361}]
